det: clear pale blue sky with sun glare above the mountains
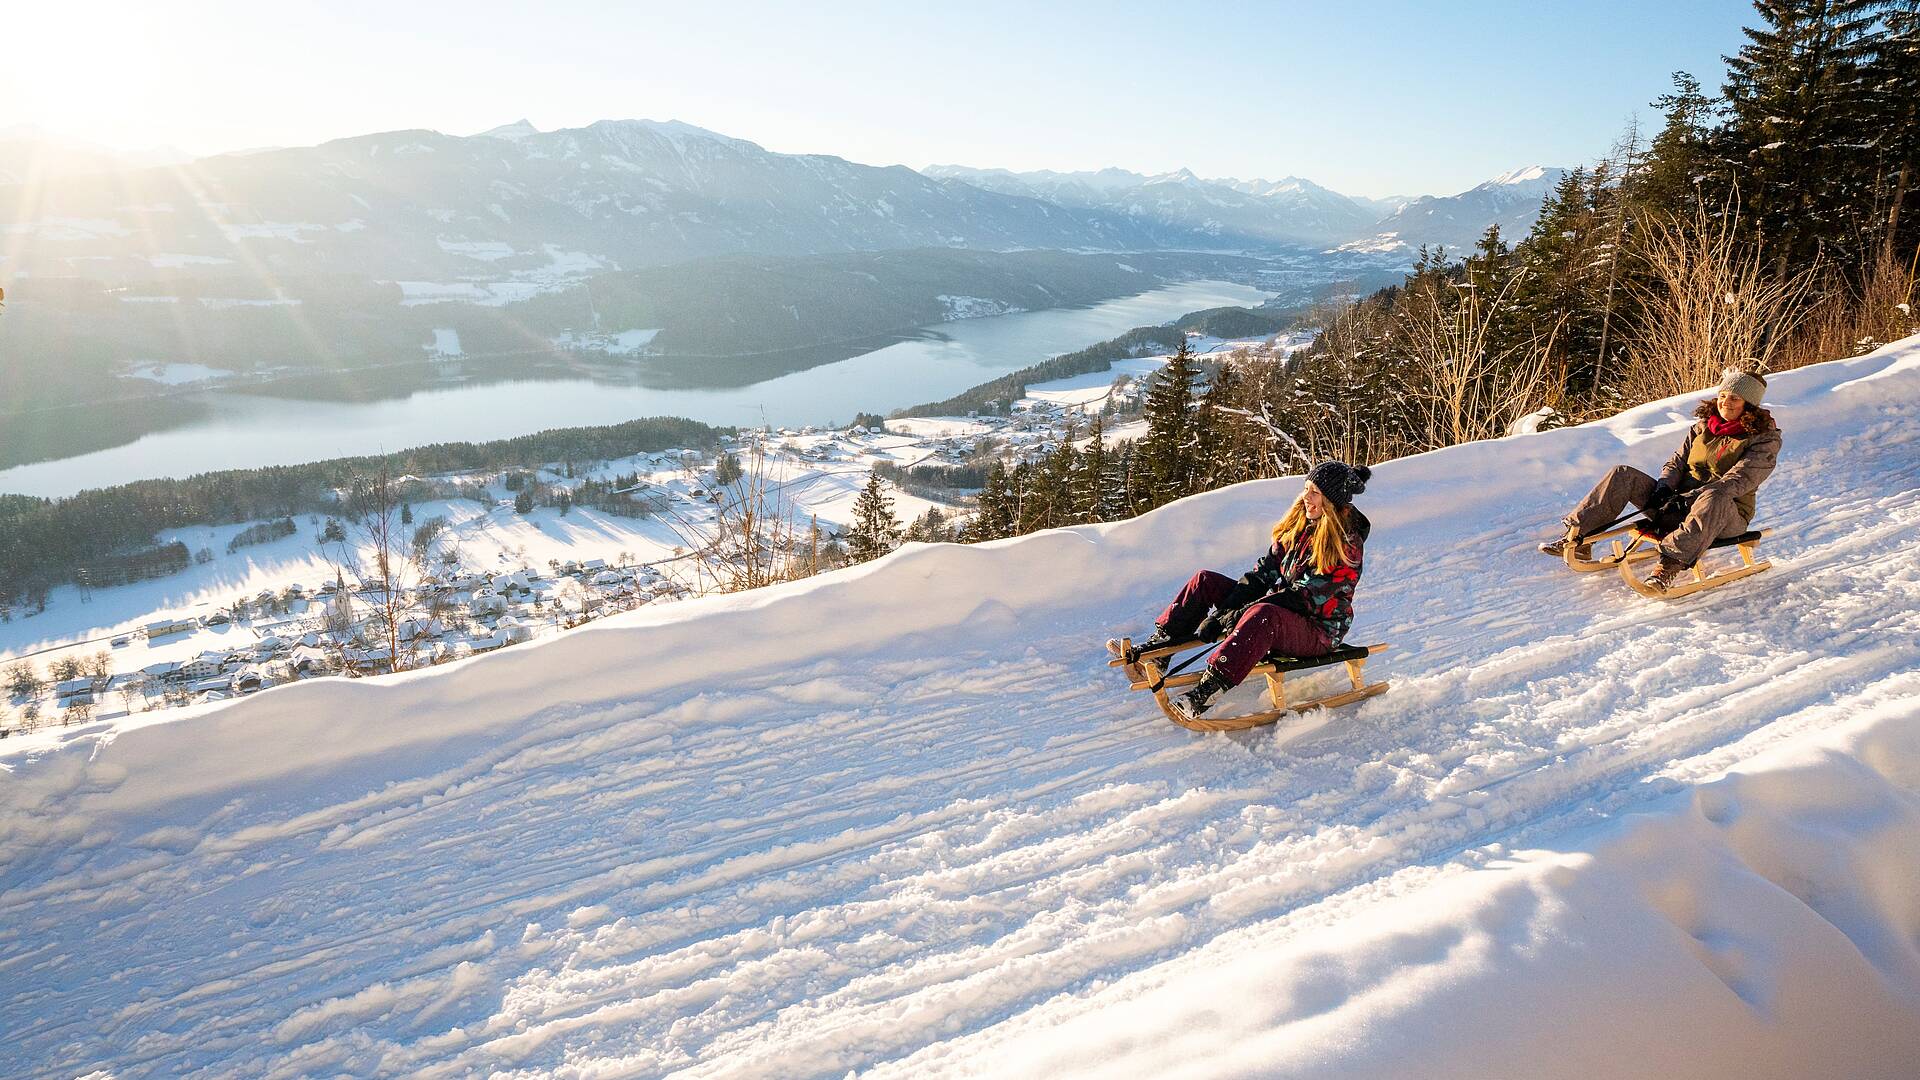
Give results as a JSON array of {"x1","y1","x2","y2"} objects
[{"x1": 0, "y1": 0, "x2": 1753, "y2": 196}]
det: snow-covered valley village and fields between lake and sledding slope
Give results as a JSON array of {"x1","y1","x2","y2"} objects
[{"x1": 0, "y1": 332, "x2": 1311, "y2": 736}]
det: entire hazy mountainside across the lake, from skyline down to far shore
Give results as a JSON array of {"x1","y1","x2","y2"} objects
[{"x1": 0, "y1": 119, "x2": 1559, "y2": 415}]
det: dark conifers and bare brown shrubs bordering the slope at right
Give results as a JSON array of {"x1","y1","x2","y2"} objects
[{"x1": 964, "y1": 0, "x2": 1920, "y2": 540}]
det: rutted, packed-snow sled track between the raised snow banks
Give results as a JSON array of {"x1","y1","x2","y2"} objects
[{"x1": 0, "y1": 386, "x2": 1920, "y2": 1078}]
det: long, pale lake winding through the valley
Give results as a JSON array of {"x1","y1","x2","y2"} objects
[{"x1": 0, "y1": 281, "x2": 1269, "y2": 498}]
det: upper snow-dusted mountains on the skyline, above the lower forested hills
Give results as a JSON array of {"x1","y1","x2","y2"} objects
[{"x1": 0, "y1": 119, "x2": 1559, "y2": 282}]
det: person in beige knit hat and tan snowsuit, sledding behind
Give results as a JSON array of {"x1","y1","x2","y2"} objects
[{"x1": 1540, "y1": 369, "x2": 1780, "y2": 592}]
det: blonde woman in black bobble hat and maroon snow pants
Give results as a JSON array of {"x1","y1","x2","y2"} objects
[{"x1": 1114, "y1": 461, "x2": 1371, "y2": 721}]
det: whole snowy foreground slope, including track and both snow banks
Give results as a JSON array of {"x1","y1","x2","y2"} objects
[{"x1": 0, "y1": 338, "x2": 1920, "y2": 1080}]
